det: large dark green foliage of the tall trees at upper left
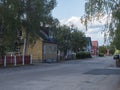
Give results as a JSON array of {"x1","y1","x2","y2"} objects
[{"x1": 0, "y1": 0, "x2": 56, "y2": 53}]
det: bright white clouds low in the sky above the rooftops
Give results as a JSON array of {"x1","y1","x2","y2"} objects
[{"x1": 60, "y1": 16, "x2": 107, "y2": 45}]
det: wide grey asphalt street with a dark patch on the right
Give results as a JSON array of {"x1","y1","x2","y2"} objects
[{"x1": 0, "y1": 56, "x2": 120, "y2": 90}]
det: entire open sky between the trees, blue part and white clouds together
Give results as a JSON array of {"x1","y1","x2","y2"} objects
[{"x1": 52, "y1": 0, "x2": 106, "y2": 46}]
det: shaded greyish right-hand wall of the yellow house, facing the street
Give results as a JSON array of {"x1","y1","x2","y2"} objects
[{"x1": 43, "y1": 43, "x2": 57, "y2": 60}]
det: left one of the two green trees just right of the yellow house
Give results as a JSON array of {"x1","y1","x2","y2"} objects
[{"x1": 54, "y1": 25, "x2": 71, "y2": 55}]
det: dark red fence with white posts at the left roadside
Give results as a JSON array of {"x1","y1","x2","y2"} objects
[{"x1": 0, "y1": 55, "x2": 32, "y2": 67}]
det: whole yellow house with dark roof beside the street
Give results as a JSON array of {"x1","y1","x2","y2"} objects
[{"x1": 27, "y1": 28, "x2": 57, "y2": 62}]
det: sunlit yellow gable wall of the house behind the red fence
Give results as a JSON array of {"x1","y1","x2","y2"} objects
[{"x1": 27, "y1": 39, "x2": 43, "y2": 61}]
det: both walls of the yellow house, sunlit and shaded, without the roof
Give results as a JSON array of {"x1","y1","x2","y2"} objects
[{"x1": 27, "y1": 39, "x2": 57, "y2": 62}]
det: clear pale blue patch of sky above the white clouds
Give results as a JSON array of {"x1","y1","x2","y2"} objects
[{"x1": 53, "y1": 0, "x2": 85, "y2": 20}]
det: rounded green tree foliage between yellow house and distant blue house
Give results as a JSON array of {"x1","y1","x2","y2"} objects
[{"x1": 55, "y1": 25, "x2": 86, "y2": 54}]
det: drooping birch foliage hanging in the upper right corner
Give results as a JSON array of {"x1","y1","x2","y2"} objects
[{"x1": 85, "y1": 0, "x2": 120, "y2": 49}]
